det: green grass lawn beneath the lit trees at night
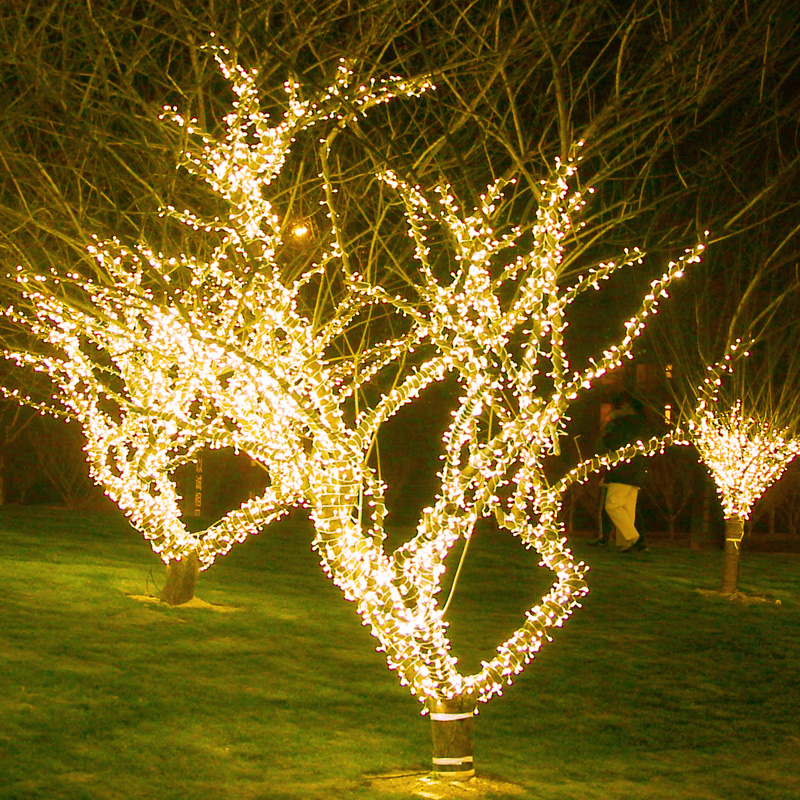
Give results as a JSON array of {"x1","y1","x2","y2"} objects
[{"x1": 0, "y1": 507, "x2": 800, "y2": 800}]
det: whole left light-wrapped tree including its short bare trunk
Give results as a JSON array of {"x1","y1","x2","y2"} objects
[{"x1": 0, "y1": 37, "x2": 434, "y2": 602}]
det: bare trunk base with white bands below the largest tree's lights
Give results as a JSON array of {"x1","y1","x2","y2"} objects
[{"x1": 428, "y1": 697, "x2": 475, "y2": 780}]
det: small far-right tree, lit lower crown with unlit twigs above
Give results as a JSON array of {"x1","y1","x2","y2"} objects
[{"x1": 650, "y1": 222, "x2": 800, "y2": 596}]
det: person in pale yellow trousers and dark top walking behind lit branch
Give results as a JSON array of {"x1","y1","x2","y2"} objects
[{"x1": 600, "y1": 392, "x2": 647, "y2": 553}]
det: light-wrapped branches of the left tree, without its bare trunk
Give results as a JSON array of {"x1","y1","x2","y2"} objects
[{"x1": 3, "y1": 42, "x2": 429, "y2": 568}]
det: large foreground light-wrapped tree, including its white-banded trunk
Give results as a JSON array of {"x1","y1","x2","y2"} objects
[{"x1": 192, "y1": 114, "x2": 701, "y2": 777}]
